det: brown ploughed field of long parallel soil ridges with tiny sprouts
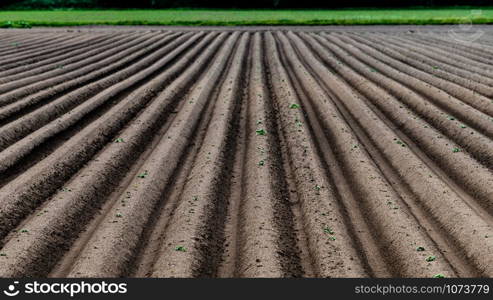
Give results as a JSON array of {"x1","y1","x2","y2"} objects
[{"x1": 0, "y1": 28, "x2": 493, "y2": 277}]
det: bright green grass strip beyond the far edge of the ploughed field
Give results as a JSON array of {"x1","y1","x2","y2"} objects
[{"x1": 0, "y1": 7, "x2": 493, "y2": 28}]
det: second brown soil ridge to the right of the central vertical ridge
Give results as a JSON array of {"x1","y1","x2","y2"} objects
[{"x1": 284, "y1": 31, "x2": 466, "y2": 277}]
